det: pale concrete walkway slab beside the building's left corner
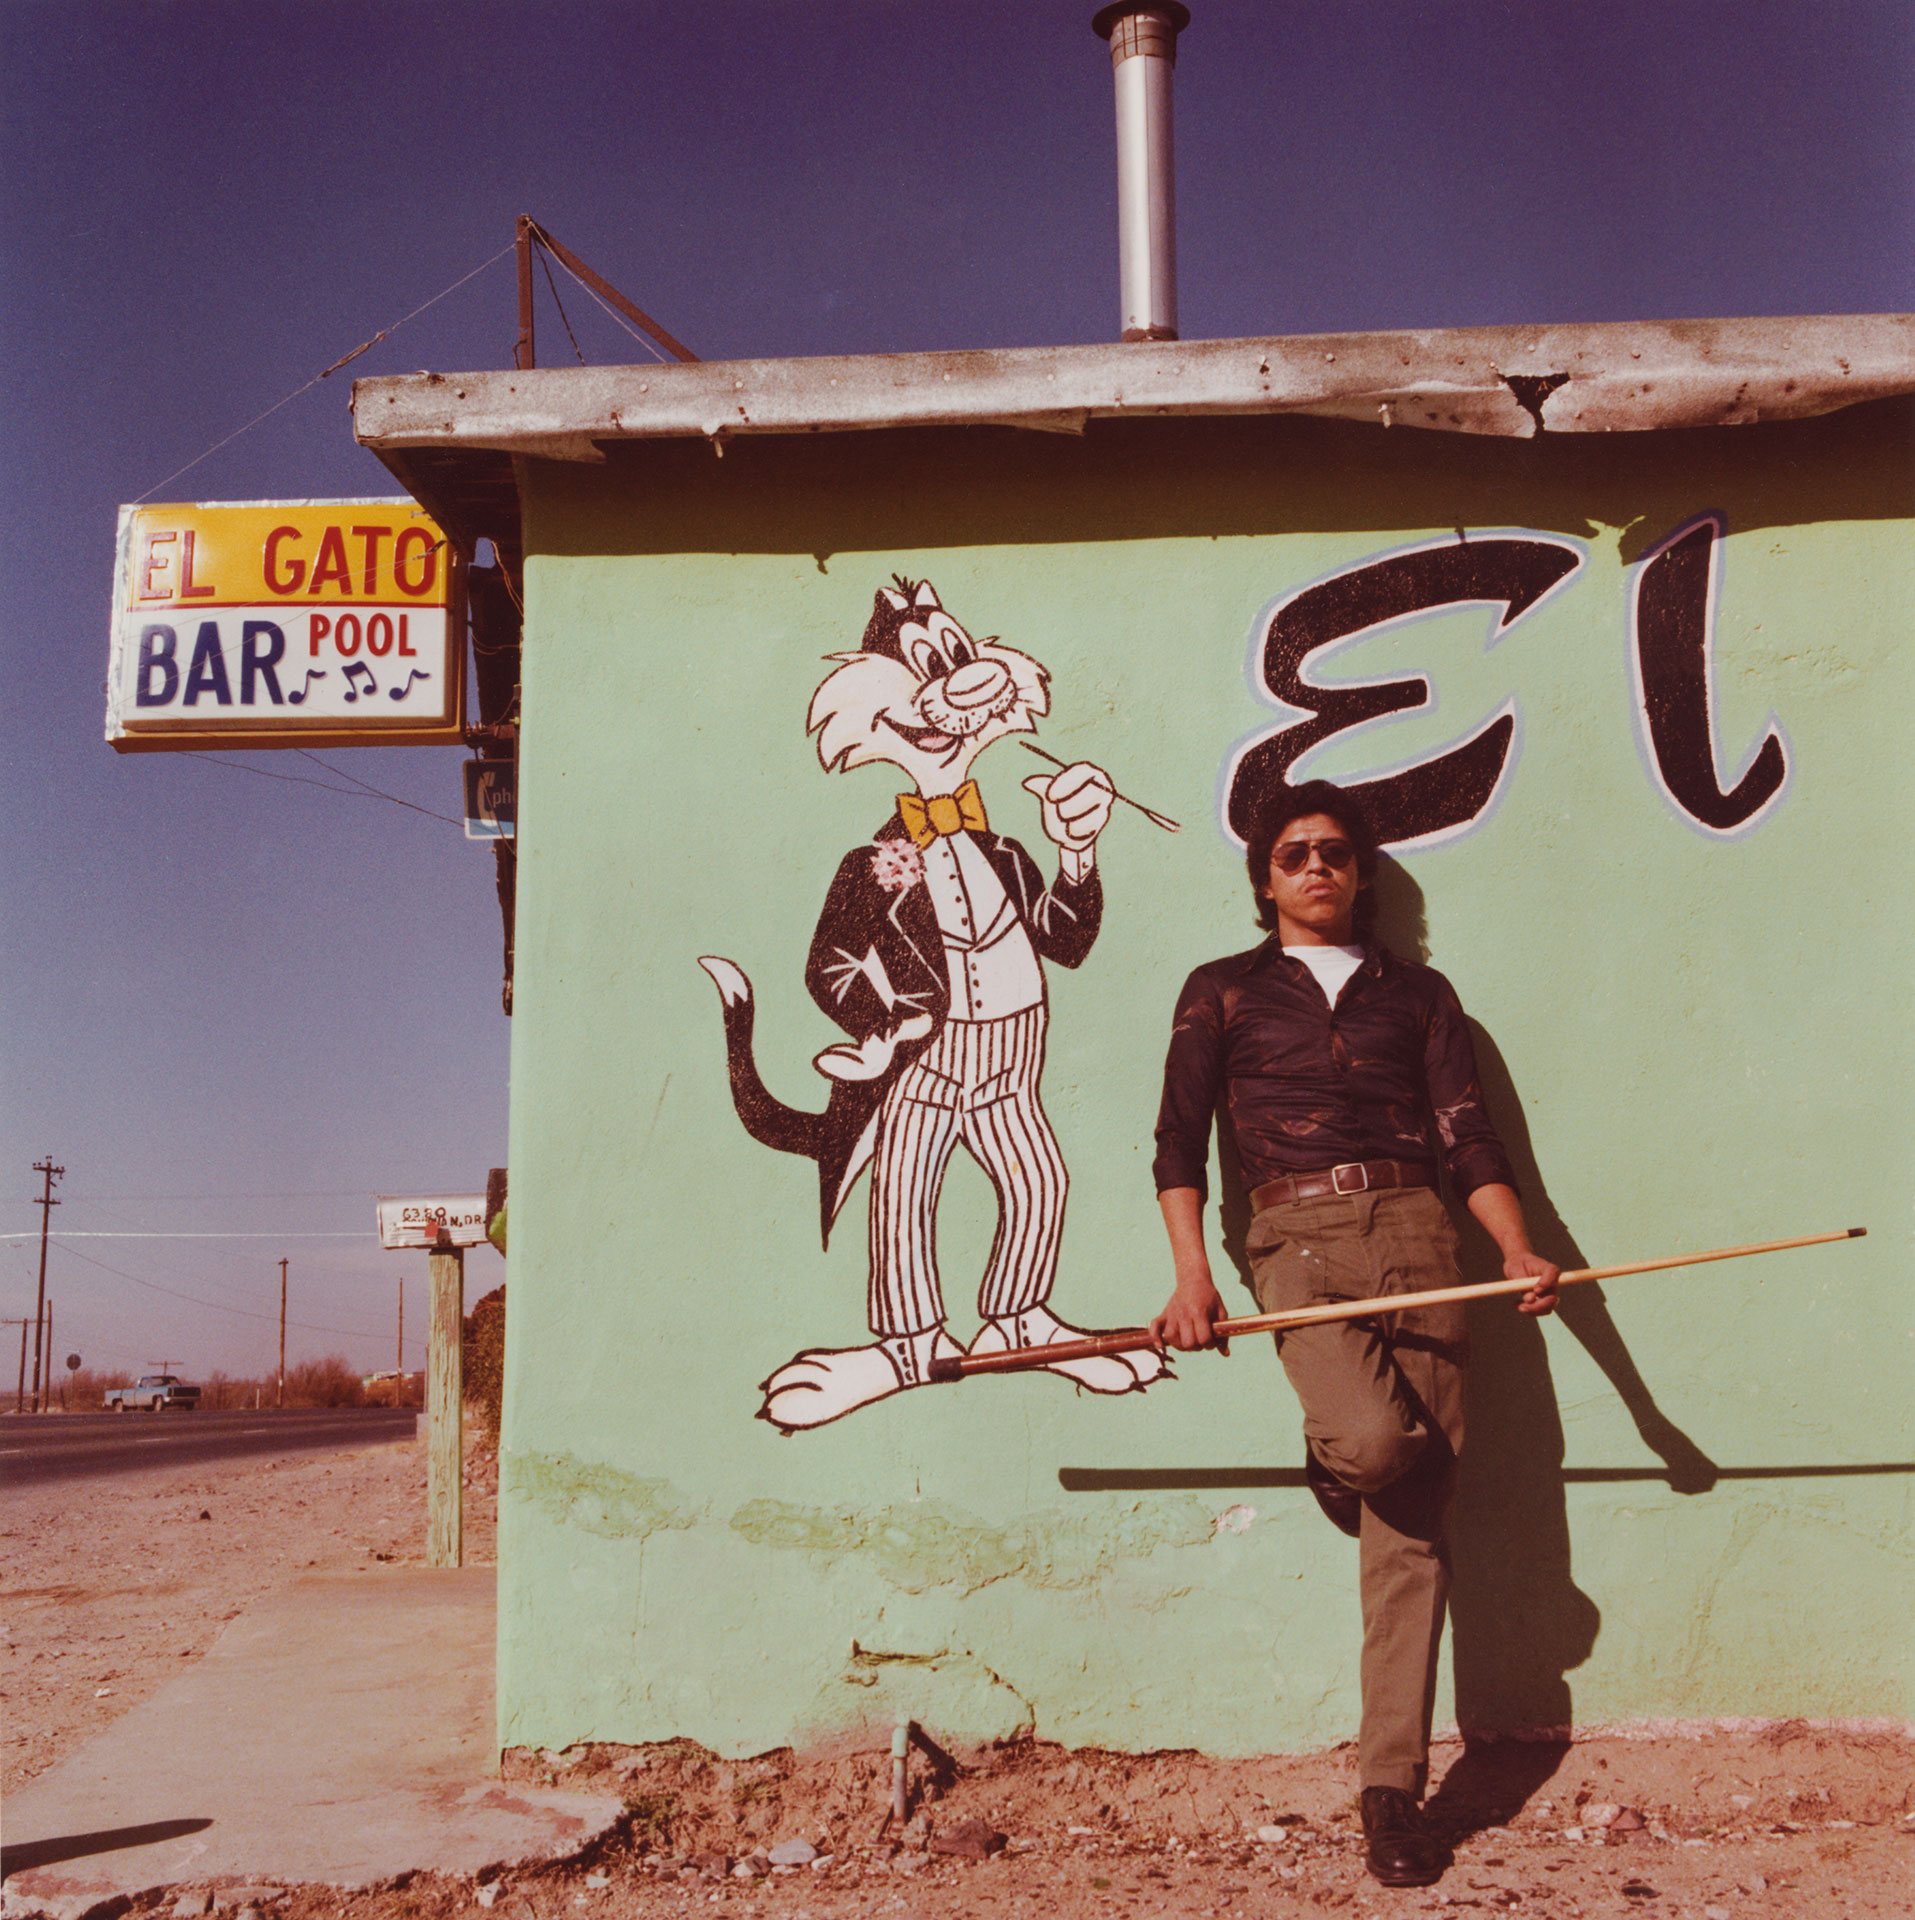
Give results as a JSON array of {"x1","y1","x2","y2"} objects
[{"x1": 4, "y1": 1567, "x2": 618, "y2": 1914}]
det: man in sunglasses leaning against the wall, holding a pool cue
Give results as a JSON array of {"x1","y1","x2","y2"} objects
[{"x1": 1151, "y1": 780, "x2": 1558, "y2": 1887}]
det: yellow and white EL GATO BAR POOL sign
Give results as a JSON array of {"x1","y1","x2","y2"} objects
[{"x1": 106, "y1": 499, "x2": 465, "y2": 753}]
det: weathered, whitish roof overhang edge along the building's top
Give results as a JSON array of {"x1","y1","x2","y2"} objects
[{"x1": 353, "y1": 313, "x2": 1915, "y2": 545}]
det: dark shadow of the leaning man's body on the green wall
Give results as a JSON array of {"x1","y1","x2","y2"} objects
[{"x1": 1220, "y1": 856, "x2": 1717, "y2": 1836}]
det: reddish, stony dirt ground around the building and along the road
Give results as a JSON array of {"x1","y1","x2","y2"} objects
[{"x1": 0, "y1": 1446, "x2": 1915, "y2": 1920}]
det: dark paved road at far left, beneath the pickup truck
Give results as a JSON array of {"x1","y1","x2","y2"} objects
[{"x1": 0, "y1": 1407, "x2": 419, "y2": 1488}]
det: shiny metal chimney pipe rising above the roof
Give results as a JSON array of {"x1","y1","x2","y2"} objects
[{"x1": 1091, "y1": 0, "x2": 1191, "y2": 340}]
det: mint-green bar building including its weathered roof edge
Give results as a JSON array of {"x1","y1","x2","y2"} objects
[{"x1": 355, "y1": 317, "x2": 1915, "y2": 1753}]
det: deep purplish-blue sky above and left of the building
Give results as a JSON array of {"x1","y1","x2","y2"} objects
[{"x1": 0, "y1": 0, "x2": 1915, "y2": 1377}]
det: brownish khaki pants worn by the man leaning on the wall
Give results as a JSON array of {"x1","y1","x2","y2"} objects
[{"x1": 1247, "y1": 1187, "x2": 1467, "y2": 1795}]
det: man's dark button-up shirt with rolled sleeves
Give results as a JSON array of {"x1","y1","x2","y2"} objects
[{"x1": 1152, "y1": 935, "x2": 1515, "y2": 1194}]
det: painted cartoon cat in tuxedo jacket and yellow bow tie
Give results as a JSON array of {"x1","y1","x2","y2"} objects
[{"x1": 699, "y1": 576, "x2": 1168, "y2": 1432}]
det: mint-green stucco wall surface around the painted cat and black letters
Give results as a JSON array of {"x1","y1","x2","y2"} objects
[{"x1": 499, "y1": 403, "x2": 1915, "y2": 1753}]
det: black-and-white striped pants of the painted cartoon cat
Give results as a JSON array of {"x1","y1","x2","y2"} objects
[{"x1": 870, "y1": 1006, "x2": 1068, "y2": 1338}]
